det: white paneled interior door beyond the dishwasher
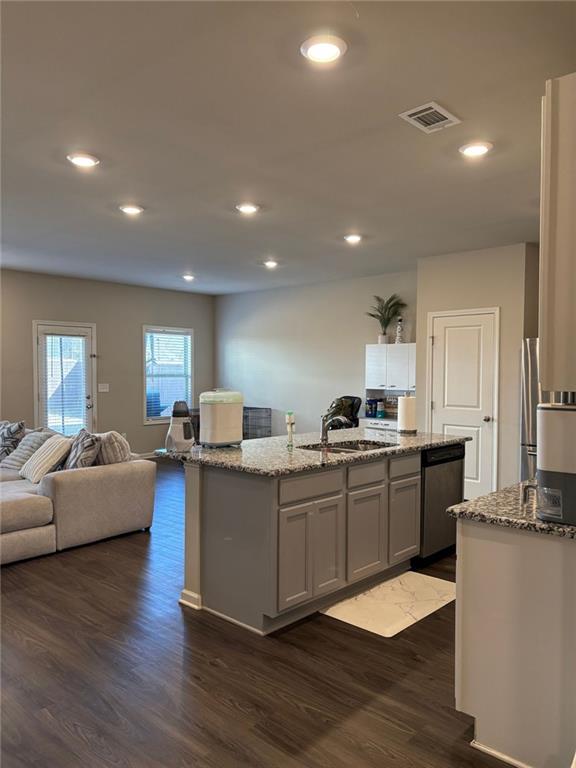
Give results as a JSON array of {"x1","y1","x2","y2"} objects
[{"x1": 430, "y1": 309, "x2": 498, "y2": 499}]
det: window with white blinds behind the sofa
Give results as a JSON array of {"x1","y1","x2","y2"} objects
[{"x1": 144, "y1": 326, "x2": 193, "y2": 423}]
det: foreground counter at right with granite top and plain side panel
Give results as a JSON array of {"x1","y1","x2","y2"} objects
[{"x1": 449, "y1": 485, "x2": 576, "y2": 768}]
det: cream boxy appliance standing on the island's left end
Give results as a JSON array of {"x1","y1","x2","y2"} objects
[{"x1": 199, "y1": 389, "x2": 244, "y2": 448}]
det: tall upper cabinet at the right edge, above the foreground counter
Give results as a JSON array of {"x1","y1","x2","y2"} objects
[{"x1": 539, "y1": 72, "x2": 576, "y2": 392}]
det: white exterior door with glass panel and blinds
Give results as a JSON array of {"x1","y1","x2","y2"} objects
[{"x1": 36, "y1": 323, "x2": 96, "y2": 435}]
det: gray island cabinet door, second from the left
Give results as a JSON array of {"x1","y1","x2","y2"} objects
[{"x1": 312, "y1": 496, "x2": 346, "y2": 597}]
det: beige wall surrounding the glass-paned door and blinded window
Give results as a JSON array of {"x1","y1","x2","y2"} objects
[{"x1": 0, "y1": 270, "x2": 215, "y2": 453}]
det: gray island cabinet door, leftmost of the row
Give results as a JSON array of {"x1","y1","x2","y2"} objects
[{"x1": 278, "y1": 503, "x2": 314, "y2": 611}]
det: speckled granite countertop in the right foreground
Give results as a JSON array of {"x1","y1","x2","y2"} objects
[{"x1": 448, "y1": 483, "x2": 576, "y2": 539}]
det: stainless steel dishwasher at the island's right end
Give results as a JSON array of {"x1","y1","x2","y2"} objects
[{"x1": 420, "y1": 444, "x2": 464, "y2": 557}]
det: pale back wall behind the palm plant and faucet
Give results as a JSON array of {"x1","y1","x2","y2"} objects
[{"x1": 216, "y1": 272, "x2": 416, "y2": 434}]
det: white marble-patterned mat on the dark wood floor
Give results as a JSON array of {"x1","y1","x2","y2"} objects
[{"x1": 323, "y1": 571, "x2": 456, "y2": 637}]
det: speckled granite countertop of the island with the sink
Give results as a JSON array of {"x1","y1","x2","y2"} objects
[{"x1": 170, "y1": 427, "x2": 469, "y2": 477}]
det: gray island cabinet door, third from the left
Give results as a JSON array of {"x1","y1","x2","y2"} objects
[{"x1": 346, "y1": 485, "x2": 388, "y2": 582}]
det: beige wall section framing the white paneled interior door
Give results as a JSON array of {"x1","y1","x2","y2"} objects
[{"x1": 416, "y1": 243, "x2": 538, "y2": 487}]
